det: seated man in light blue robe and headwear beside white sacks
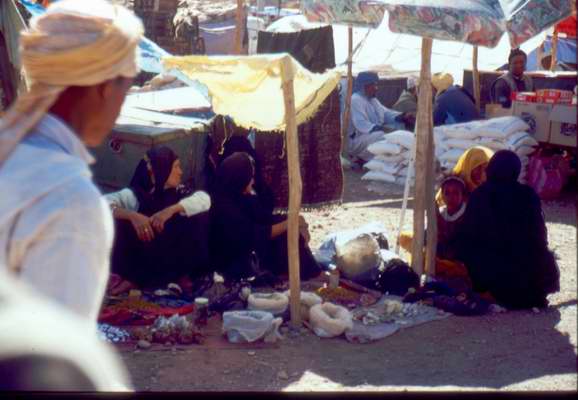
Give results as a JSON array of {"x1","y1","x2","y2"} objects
[{"x1": 348, "y1": 72, "x2": 415, "y2": 164}]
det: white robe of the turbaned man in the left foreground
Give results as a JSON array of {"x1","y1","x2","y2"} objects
[{"x1": 0, "y1": 114, "x2": 114, "y2": 324}]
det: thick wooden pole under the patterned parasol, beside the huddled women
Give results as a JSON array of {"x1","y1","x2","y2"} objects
[{"x1": 411, "y1": 38, "x2": 432, "y2": 276}]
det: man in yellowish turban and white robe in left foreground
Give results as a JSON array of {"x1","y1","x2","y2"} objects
[{"x1": 0, "y1": 0, "x2": 143, "y2": 324}]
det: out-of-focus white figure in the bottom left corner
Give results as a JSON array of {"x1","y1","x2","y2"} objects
[{"x1": 0, "y1": 270, "x2": 131, "y2": 392}]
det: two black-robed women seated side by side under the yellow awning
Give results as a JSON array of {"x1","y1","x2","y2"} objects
[{"x1": 106, "y1": 136, "x2": 321, "y2": 295}]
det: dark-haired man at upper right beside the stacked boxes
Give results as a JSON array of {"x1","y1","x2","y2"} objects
[{"x1": 490, "y1": 49, "x2": 534, "y2": 108}]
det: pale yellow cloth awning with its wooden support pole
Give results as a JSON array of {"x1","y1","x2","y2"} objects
[{"x1": 164, "y1": 54, "x2": 339, "y2": 326}]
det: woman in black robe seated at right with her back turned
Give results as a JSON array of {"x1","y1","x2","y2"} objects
[{"x1": 456, "y1": 150, "x2": 560, "y2": 309}]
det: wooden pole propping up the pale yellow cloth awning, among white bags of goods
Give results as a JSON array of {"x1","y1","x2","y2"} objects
[{"x1": 281, "y1": 57, "x2": 302, "y2": 327}]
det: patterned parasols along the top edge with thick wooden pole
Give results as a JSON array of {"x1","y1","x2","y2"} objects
[{"x1": 302, "y1": 0, "x2": 575, "y2": 274}]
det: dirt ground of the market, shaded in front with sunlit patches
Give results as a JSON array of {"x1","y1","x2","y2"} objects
[{"x1": 121, "y1": 171, "x2": 578, "y2": 391}]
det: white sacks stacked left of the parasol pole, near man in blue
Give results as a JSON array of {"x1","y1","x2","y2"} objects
[{"x1": 361, "y1": 130, "x2": 447, "y2": 186}]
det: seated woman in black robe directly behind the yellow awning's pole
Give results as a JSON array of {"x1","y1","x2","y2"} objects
[{"x1": 210, "y1": 152, "x2": 321, "y2": 280}]
